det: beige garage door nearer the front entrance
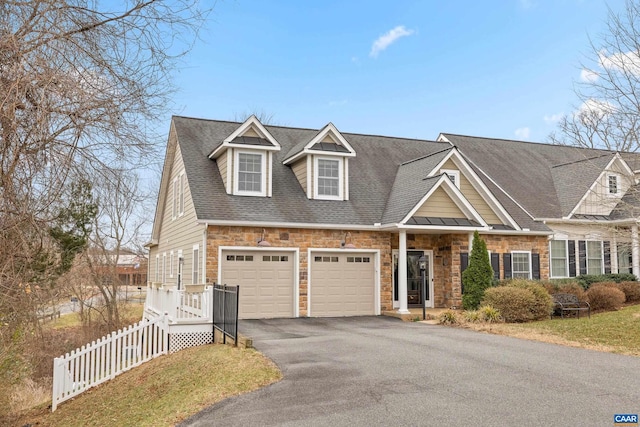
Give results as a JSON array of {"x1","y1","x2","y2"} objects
[{"x1": 309, "y1": 252, "x2": 376, "y2": 317}]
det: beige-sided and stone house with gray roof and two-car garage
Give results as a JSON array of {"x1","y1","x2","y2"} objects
[{"x1": 148, "y1": 116, "x2": 640, "y2": 318}]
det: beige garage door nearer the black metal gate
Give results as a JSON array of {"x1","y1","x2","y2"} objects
[{"x1": 221, "y1": 251, "x2": 295, "y2": 319}]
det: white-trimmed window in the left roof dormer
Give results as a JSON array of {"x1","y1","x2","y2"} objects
[{"x1": 234, "y1": 150, "x2": 267, "y2": 196}]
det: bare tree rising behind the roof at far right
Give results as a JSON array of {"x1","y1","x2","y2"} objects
[{"x1": 549, "y1": 0, "x2": 640, "y2": 152}]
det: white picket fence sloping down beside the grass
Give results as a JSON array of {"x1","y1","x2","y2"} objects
[{"x1": 51, "y1": 316, "x2": 169, "y2": 412}]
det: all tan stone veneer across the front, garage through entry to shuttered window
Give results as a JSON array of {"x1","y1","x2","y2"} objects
[{"x1": 206, "y1": 225, "x2": 549, "y2": 316}]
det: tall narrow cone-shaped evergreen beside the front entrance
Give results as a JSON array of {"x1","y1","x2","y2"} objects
[{"x1": 462, "y1": 231, "x2": 493, "y2": 310}]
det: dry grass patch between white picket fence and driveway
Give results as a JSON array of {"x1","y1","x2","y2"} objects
[{"x1": 8, "y1": 345, "x2": 281, "y2": 427}]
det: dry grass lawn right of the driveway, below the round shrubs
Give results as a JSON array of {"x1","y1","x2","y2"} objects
[{"x1": 465, "y1": 305, "x2": 640, "y2": 356}]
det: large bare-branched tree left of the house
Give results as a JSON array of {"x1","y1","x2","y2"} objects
[{"x1": 0, "y1": 0, "x2": 208, "y2": 338}]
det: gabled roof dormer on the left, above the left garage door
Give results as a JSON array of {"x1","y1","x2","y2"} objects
[{"x1": 209, "y1": 116, "x2": 280, "y2": 197}]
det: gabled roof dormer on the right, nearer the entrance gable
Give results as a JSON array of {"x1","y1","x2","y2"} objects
[{"x1": 283, "y1": 123, "x2": 356, "y2": 200}]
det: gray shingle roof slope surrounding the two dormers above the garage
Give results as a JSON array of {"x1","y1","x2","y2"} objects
[{"x1": 173, "y1": 117, "x2": 456, "y2": 225}]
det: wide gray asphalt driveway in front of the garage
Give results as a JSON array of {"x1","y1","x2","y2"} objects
[{"x1": 183, "y1": 317, "x2": 640, "y2": 427}]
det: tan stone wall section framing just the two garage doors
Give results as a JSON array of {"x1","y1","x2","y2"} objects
[{"x1": 206, "y1": 225, "x2": 397, "y2": 316}]
